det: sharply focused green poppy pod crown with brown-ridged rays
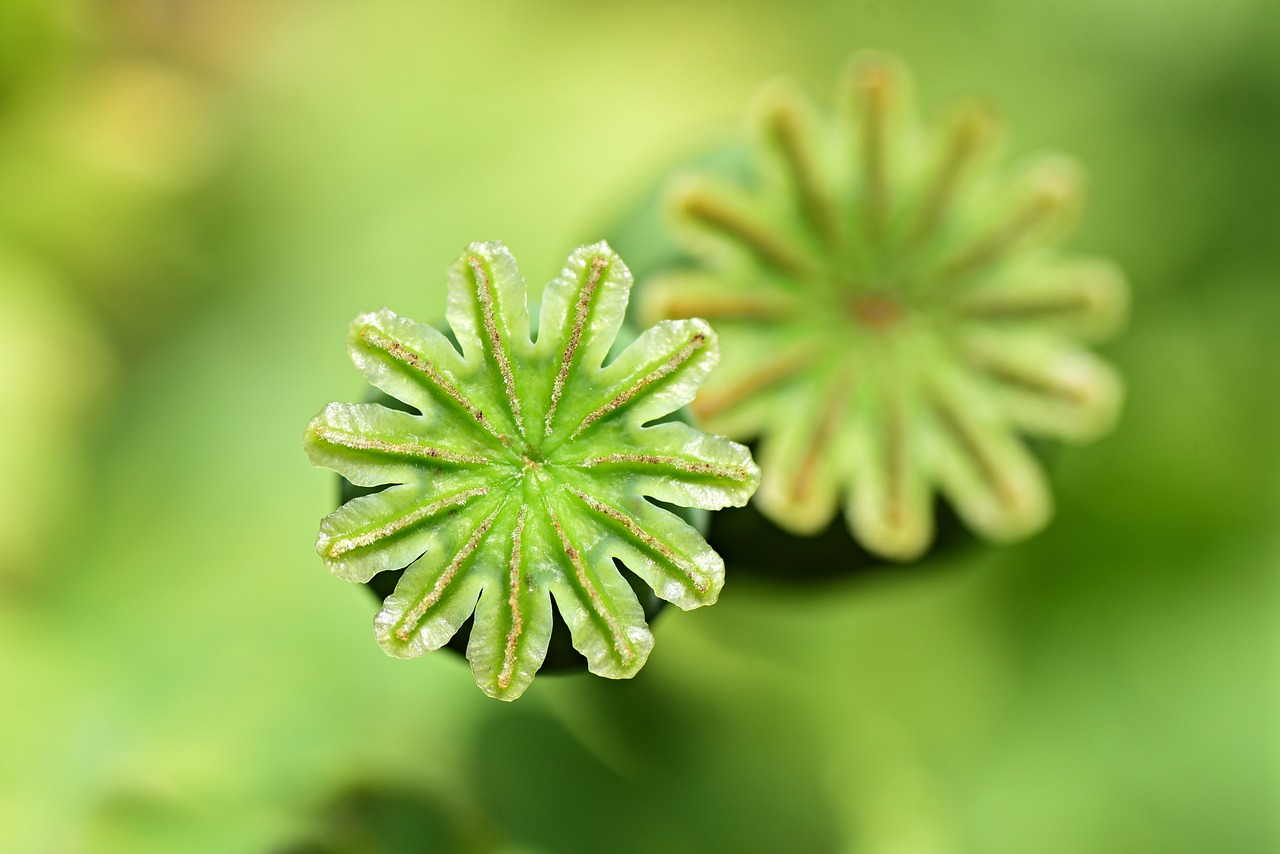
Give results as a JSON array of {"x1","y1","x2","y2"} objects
[{"x1": 305, "y1": 243, "x2": 759, "y2": 699}]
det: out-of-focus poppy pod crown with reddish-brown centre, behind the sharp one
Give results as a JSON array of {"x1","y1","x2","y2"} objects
[{"x1": 640, "y1": 51, "x2": 1128, "y2": 561}]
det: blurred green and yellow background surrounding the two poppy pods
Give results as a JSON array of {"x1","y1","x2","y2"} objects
[{"x1": 0, "y1": 0, "x2": 1280, "y2": 854}]
